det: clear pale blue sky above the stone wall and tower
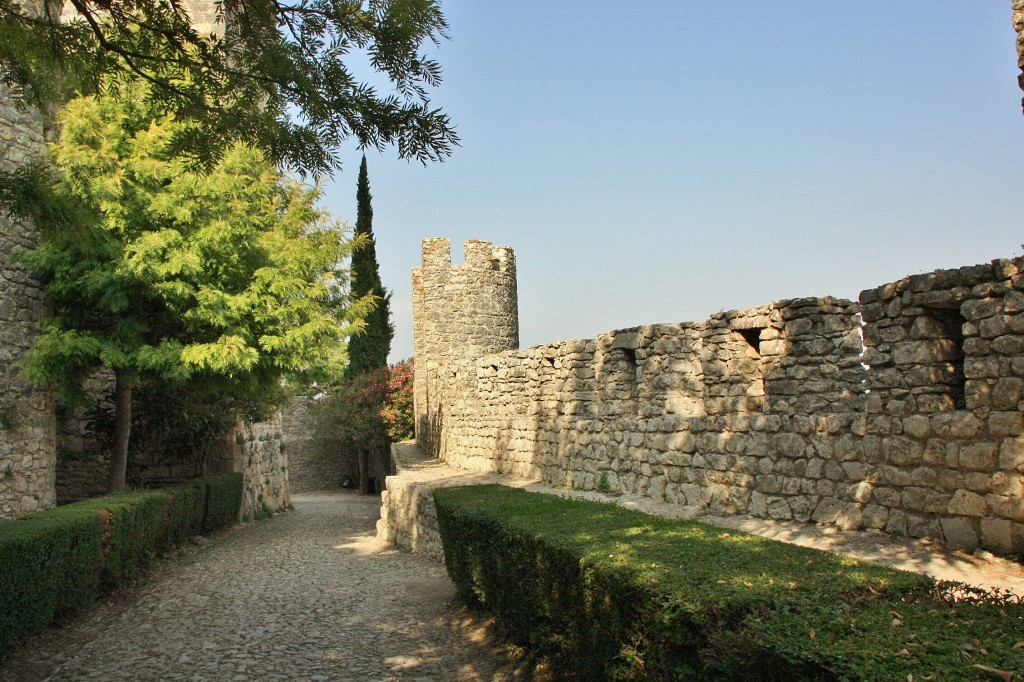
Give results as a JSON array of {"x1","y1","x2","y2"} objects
[{"x1": 326, "y1": 0, "x2": 1024, "y2": 359}]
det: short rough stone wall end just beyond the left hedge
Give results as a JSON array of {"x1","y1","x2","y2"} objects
[{"x1": 217, "y1": 412, "x2": 292, "y2": 519}]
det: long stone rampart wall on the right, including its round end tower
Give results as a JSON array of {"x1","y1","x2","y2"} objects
[{"x1": 414, "y1": 240, "x2": 1024, "y2": 552}]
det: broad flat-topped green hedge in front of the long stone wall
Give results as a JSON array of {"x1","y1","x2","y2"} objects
[{"x1": 434, "y1": 485, "x2": 1024, "y2": 680}]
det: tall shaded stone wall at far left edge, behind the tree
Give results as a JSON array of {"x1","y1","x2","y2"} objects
[{"x1": 0, "y1": 75, "x2": 56, "y2": 519}]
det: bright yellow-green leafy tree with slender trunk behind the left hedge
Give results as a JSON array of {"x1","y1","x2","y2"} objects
[{"x1": 22, "y1": 83, "x2": 372, "y2": 488}]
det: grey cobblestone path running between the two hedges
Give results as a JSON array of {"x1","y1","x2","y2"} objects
[{"x1": 6, "y1": 493, "x2": 528, "y2": 682}]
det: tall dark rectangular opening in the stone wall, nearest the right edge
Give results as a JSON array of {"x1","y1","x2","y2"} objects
[{"x1": 910, "y1": 307, "x2": 967, "y2": 411}]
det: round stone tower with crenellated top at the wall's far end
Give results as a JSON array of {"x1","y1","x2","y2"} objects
[{"x1": 413, "y1": 239, "x2": 519, "y2": 459}]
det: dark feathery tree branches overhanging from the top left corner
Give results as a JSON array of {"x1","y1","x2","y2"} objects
[{"x1": 0, "y1": 0, "x2": 458, "y2": 175}]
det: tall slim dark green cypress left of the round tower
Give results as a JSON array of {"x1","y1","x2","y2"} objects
[{"x1": 345, "y1": 156, "x2": 394, "y2": 378}]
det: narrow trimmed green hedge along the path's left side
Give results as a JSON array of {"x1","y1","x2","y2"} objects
[{"x1": 0, "y1": 473, "x2": 242, "y2": 656}]
